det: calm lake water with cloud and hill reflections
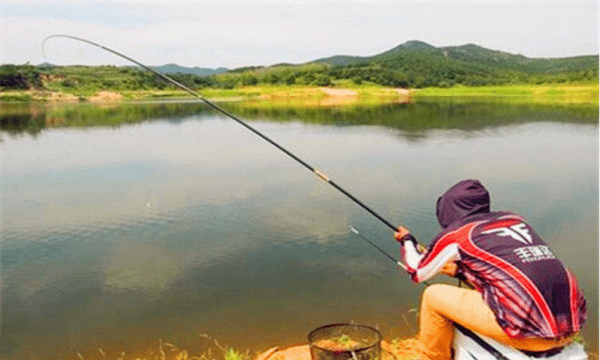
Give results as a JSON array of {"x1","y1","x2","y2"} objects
[{"x1": 0, "y1": 102, "x2": 599, "y2": 359}]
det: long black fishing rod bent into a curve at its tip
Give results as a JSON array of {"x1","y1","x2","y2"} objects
[{"x1": 42, "y1": 34, "x2": 398, "y2": 232}]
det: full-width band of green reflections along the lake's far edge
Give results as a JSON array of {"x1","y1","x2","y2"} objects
[{"x1": 0, "y1": 99, "x2": 598, "y2": 136}]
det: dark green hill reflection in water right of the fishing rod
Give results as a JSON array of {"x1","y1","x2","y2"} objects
[{"x1": 227, "y1": 99, "x2": 598, "y2": 135}]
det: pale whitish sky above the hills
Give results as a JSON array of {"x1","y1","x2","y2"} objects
[{"x1": 0, "y1": 0, "x2": 599, "y2": 69}]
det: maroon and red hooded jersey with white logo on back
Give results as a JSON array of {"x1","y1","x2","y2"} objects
[{"x1": 403, "y1": 180, "x2": 586, "y2": 339}]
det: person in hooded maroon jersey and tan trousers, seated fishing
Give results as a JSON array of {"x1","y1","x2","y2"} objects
[{"x1": 395, "y1": 180, "x2": 586, "y2": 360}]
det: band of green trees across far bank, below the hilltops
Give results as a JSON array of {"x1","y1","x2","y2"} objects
[{"x1": 0, "y1": 57, "x2": 598, "y2": 93}]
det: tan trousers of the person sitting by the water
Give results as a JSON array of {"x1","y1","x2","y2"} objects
[{"x1": 419, "y1": 284, "x2": 571, "y2": 360}]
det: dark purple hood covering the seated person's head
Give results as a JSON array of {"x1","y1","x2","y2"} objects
[{"x1": 436, "y1": 180, "x2": 490, "y2": 229}]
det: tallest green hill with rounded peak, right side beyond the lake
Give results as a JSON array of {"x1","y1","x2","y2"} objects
[{"x1": 314, "y1": 40, "x2": 598, "y2": 87}]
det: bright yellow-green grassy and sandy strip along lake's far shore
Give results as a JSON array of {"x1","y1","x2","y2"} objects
[{"x1": 0, "y1": 83, "x2": 599, "y2": 107}]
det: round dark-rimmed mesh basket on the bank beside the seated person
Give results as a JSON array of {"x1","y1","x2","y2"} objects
[{"x1": 308, "y1": 324, "x2": 381, "y2": 360}]
